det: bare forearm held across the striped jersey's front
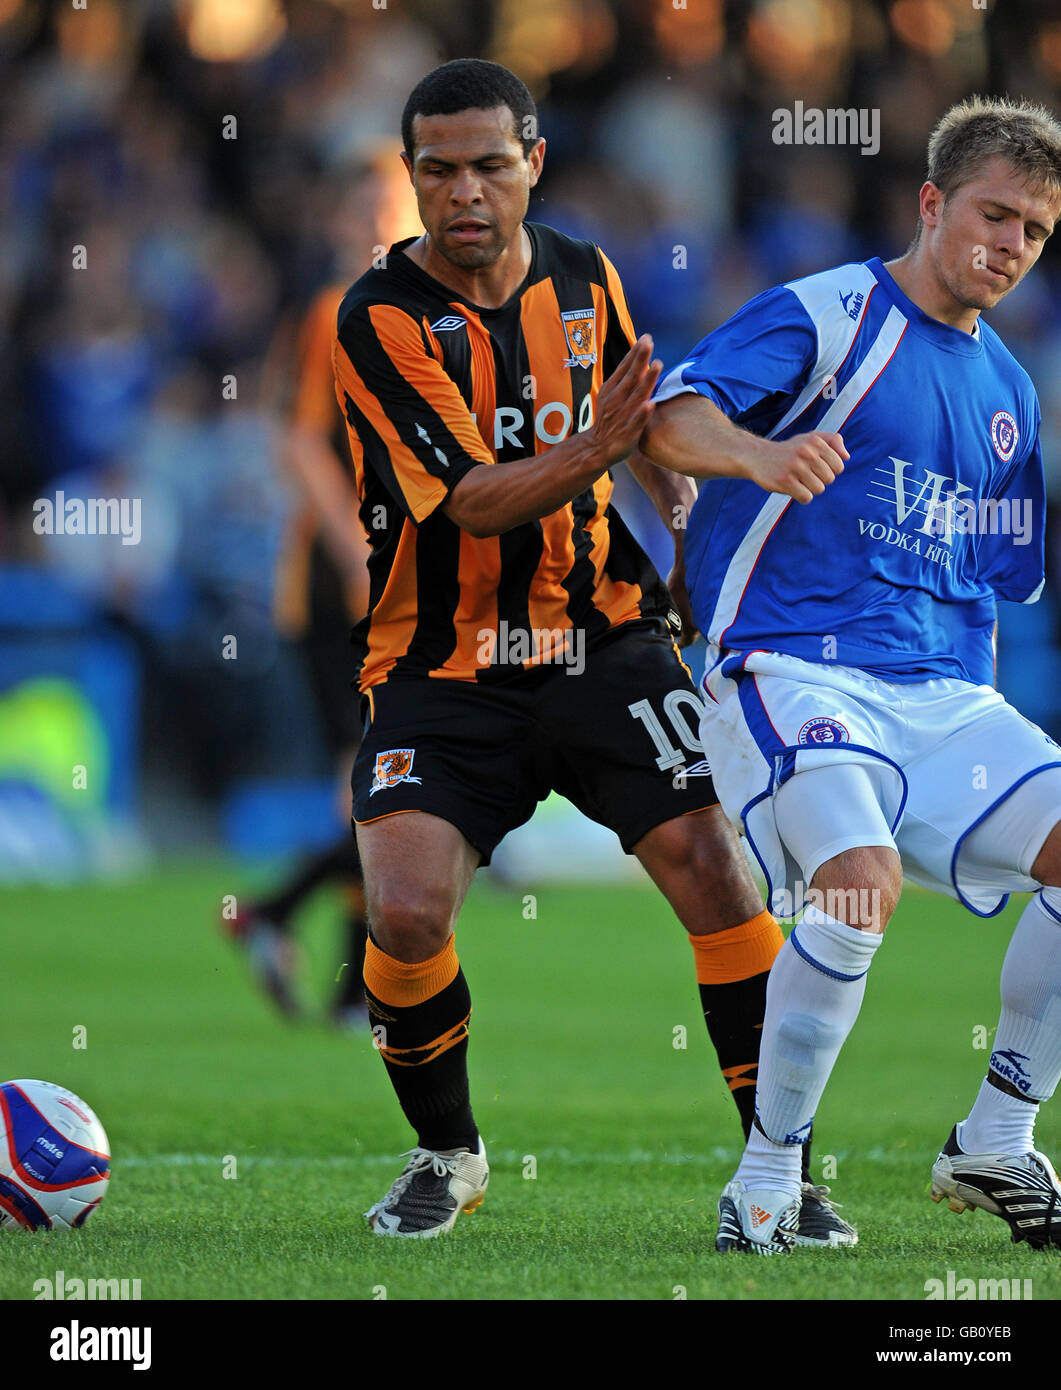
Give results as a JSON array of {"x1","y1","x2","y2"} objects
[{"x1": 444, "y1": 434, "x2": 608, "y2": 537}]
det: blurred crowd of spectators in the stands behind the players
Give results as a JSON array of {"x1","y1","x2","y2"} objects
[{"x1": 0, "y1": 0, "x2": 1061, "y2": 834}]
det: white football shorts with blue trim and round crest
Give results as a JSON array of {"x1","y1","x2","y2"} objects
[{"x1": 701, "y1": 652, "x2": 1061, "y2": 917}]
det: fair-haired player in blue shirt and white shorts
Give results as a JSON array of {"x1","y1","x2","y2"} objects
[{"x1": 641, "y1": 97, "x2": 1061, "y2": 1254}]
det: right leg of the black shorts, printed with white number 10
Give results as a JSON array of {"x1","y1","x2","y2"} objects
[{"x1": 538, "y1": 624, "x2": 718, "y2": 853}]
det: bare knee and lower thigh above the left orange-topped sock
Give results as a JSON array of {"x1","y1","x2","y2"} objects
[{"x1": 357, "y1": 810, "x2": 480, "y2": 960}]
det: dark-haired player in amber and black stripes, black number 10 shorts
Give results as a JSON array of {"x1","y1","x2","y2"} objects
[{"x1": 335, "y1": 60, "x2": 855, "y2": 1243}]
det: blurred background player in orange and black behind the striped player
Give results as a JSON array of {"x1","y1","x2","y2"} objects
[{"x1": 222, "y1": 152, "x2": 416, "y2": 1029}]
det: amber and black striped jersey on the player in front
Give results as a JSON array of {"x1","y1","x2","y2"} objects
[{"x1": 335, "y1": 222, "x2": 670, "y2": 691}]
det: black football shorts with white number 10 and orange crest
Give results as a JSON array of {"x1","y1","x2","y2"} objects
[{"x1": 353, "y1": 619, "x2": 718, "y2": 865}]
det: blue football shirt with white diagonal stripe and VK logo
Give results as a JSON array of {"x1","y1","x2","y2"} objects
[{"x1": 656, "y1": 260, "x2": 1046, "y2": 684}]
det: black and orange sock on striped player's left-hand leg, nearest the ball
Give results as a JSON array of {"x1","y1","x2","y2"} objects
[{"x1": 364, "y1": 937, "x2": 478, "y2": 1152}]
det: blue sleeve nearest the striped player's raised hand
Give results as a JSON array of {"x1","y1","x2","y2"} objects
[{"x1": 655, "y1": 285, "x2": 818, "y2": 424}]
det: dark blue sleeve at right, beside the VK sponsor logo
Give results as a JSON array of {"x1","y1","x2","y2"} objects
[{"x1": 976, "y1": 421, "x2": 1046, "y2": 603}]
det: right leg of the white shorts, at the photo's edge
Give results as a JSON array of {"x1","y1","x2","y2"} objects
[{"x1": 898, "y1": 687, "x2": 1061, "y2": 915}]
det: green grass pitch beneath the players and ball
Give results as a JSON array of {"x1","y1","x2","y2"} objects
[{"x1": 0, "y1": 862, "x2": 1061, "y2": 1308}]
